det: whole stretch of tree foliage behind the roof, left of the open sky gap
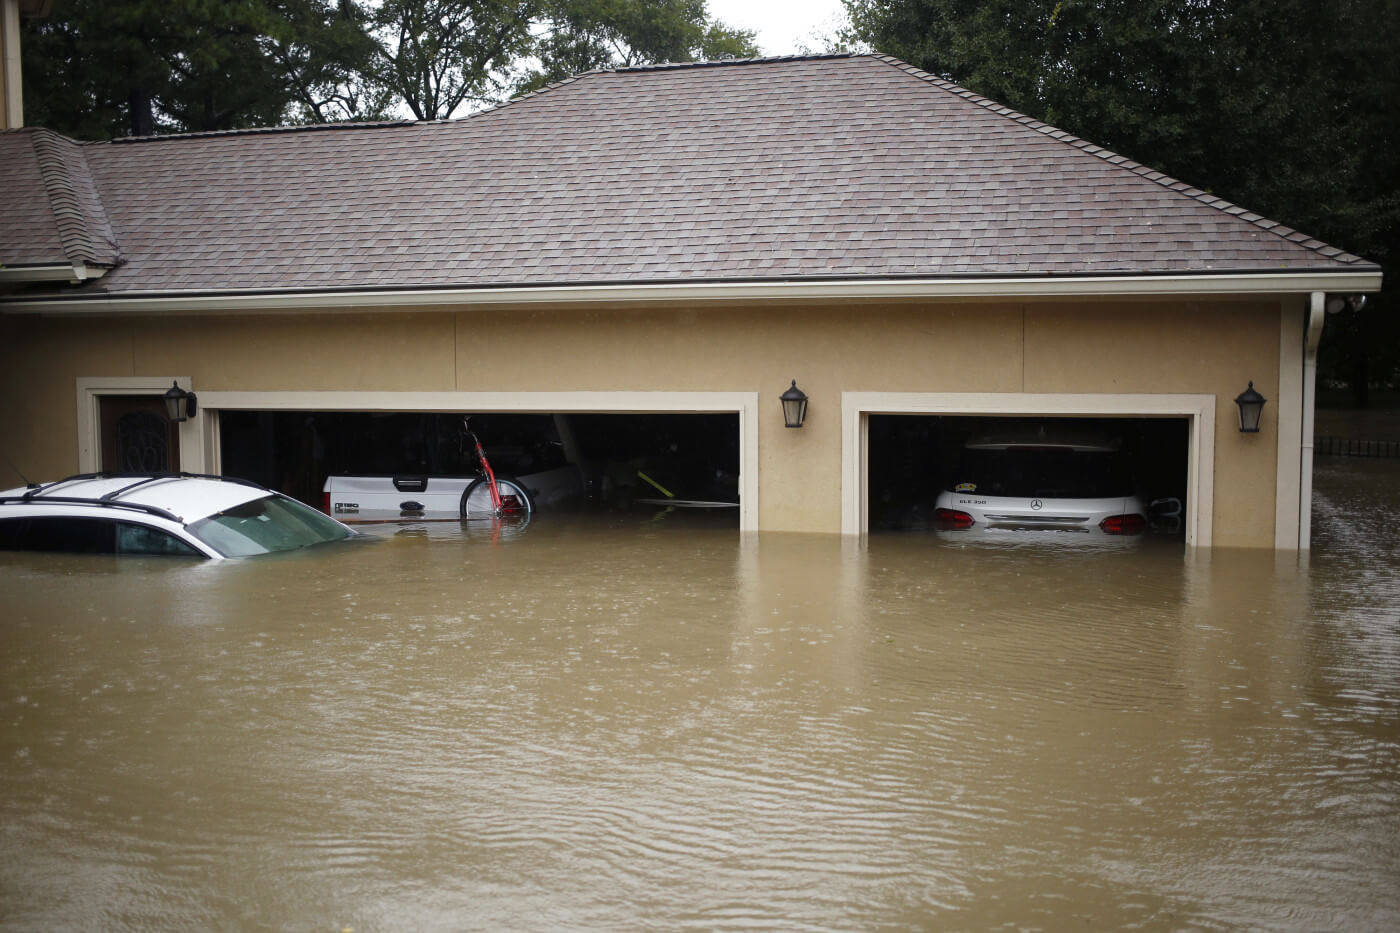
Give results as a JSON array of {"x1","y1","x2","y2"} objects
[{"x1": 22, "y1": 0, "x2": 757, "y2": 132}]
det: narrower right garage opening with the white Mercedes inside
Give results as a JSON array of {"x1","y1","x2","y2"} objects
[{"x1": 867, "y1": 415, "x2": 1190, "y2": 542}]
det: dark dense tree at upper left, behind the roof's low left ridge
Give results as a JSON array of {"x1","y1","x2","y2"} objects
[{"x1": 22, "y1": 0, "x2": 372, "y2": 139}]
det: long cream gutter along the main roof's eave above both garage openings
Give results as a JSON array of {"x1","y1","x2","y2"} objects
[{"x1": 0, "y1": 269, "x2": 1380, "y2": 314}]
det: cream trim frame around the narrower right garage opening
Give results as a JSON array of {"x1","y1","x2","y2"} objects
[{"x1": 841, "y1": 392, "x2": 1215, "y2": 548}]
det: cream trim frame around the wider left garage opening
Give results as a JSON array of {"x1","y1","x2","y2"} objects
[{"x1": 172, "y1": 389, "x2": 759, "y2": 531}]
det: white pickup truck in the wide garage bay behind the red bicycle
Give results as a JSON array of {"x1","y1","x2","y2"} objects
[{"x1": 322, "y1": 465, "x2": 584, "y2": 524}]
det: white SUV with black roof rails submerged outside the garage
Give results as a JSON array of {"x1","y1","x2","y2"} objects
[{"x1": 0, "y1": 474, "x2": 354, "y2": 559}]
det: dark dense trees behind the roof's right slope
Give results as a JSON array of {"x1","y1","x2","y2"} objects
[{"x1": 844, "y1": 0, "x2": 1400, "y2": 399}]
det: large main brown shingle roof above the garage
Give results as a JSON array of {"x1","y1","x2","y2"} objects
[{"x1": 0, "y1": 56, "x2": 1373, "y2": 294}]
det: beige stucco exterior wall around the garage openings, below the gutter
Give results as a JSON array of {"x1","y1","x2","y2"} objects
[{"x1": 0, "y1": 300, "x2": 1281, "y2": 546}]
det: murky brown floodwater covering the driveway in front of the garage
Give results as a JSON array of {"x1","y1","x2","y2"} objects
[{"x1": 0, "y1": 459, "x2": 1400, "y2": 933}]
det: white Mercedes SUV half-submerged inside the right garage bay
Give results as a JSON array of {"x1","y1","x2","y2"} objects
[{"x1": 934, "y1": 424, "x2": 1147, "y2": 537}]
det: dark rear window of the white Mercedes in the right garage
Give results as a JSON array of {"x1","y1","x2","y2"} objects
[{"x1": 958, "y1": 447, "x2": 1133, "y2": 499}]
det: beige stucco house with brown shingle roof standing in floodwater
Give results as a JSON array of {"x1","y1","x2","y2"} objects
[{"x1": 0, "y1": 55, "x2": 1380, "y2": 551}]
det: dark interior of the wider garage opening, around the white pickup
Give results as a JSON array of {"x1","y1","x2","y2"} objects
[{"x1": 218, "y1": 410, "x2": 741, "y2": 527}]
